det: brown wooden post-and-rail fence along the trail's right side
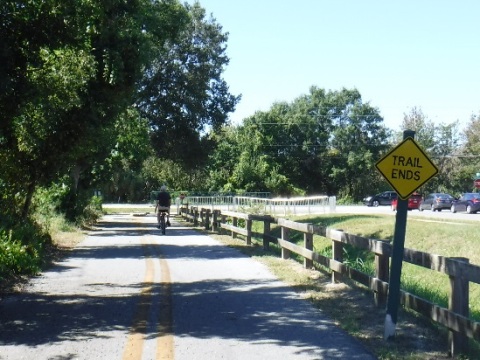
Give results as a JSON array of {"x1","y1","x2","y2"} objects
[{"x1": 181, "y1": 207, "x2": 480, "y2": 356}]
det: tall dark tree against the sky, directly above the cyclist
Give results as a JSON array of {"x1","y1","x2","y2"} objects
[{"x1": 138, "y1": 2, "x2": 239, "y2": 168}]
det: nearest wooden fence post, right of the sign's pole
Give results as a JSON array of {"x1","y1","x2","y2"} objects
[{"x1": 448, "y1": 257, "x2": 470, "y2": 358}]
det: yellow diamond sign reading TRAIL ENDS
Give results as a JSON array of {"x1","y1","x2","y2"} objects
[{"x1": 375, "y1": 137, "x2": 438, "y2": 199}]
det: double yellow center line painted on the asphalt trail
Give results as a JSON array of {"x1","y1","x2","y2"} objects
[{"x1": 122, "y1": 222, "x2": 174, "y2": 360}]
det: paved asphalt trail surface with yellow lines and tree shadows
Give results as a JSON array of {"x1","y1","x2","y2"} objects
[{"x1": 0, "y1": 215, "x2": 375, "y2": 360}]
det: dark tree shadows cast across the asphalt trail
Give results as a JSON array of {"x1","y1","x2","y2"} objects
[{"x1": 0, "y1": 214, "x2": 373, "y2": 359}]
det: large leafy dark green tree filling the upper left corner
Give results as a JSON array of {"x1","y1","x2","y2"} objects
[{"x1": 0, "y1": 0, "x2": 187, "y2": 216}]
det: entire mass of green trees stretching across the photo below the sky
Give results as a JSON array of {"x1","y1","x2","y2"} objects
[{"x1": 0, "y1": 0, "x2": 480, "y2": 222}]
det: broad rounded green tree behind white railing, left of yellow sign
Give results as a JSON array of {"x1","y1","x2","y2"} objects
[{"x1": 214, "y1": 87, "x2": 389, "y2": 199}]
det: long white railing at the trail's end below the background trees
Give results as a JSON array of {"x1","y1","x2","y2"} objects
[{"x1": 176, "y1": 195, "x2": 336, "y2": 215}]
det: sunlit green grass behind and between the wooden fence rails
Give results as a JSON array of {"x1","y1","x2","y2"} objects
[{"x1": 266, "y1": 214, "x2": 480, "y2": 320}]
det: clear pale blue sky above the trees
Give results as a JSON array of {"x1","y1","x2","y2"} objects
[{"x1": 187, "y1": 0, "x2": 480, "y2": 130}]
